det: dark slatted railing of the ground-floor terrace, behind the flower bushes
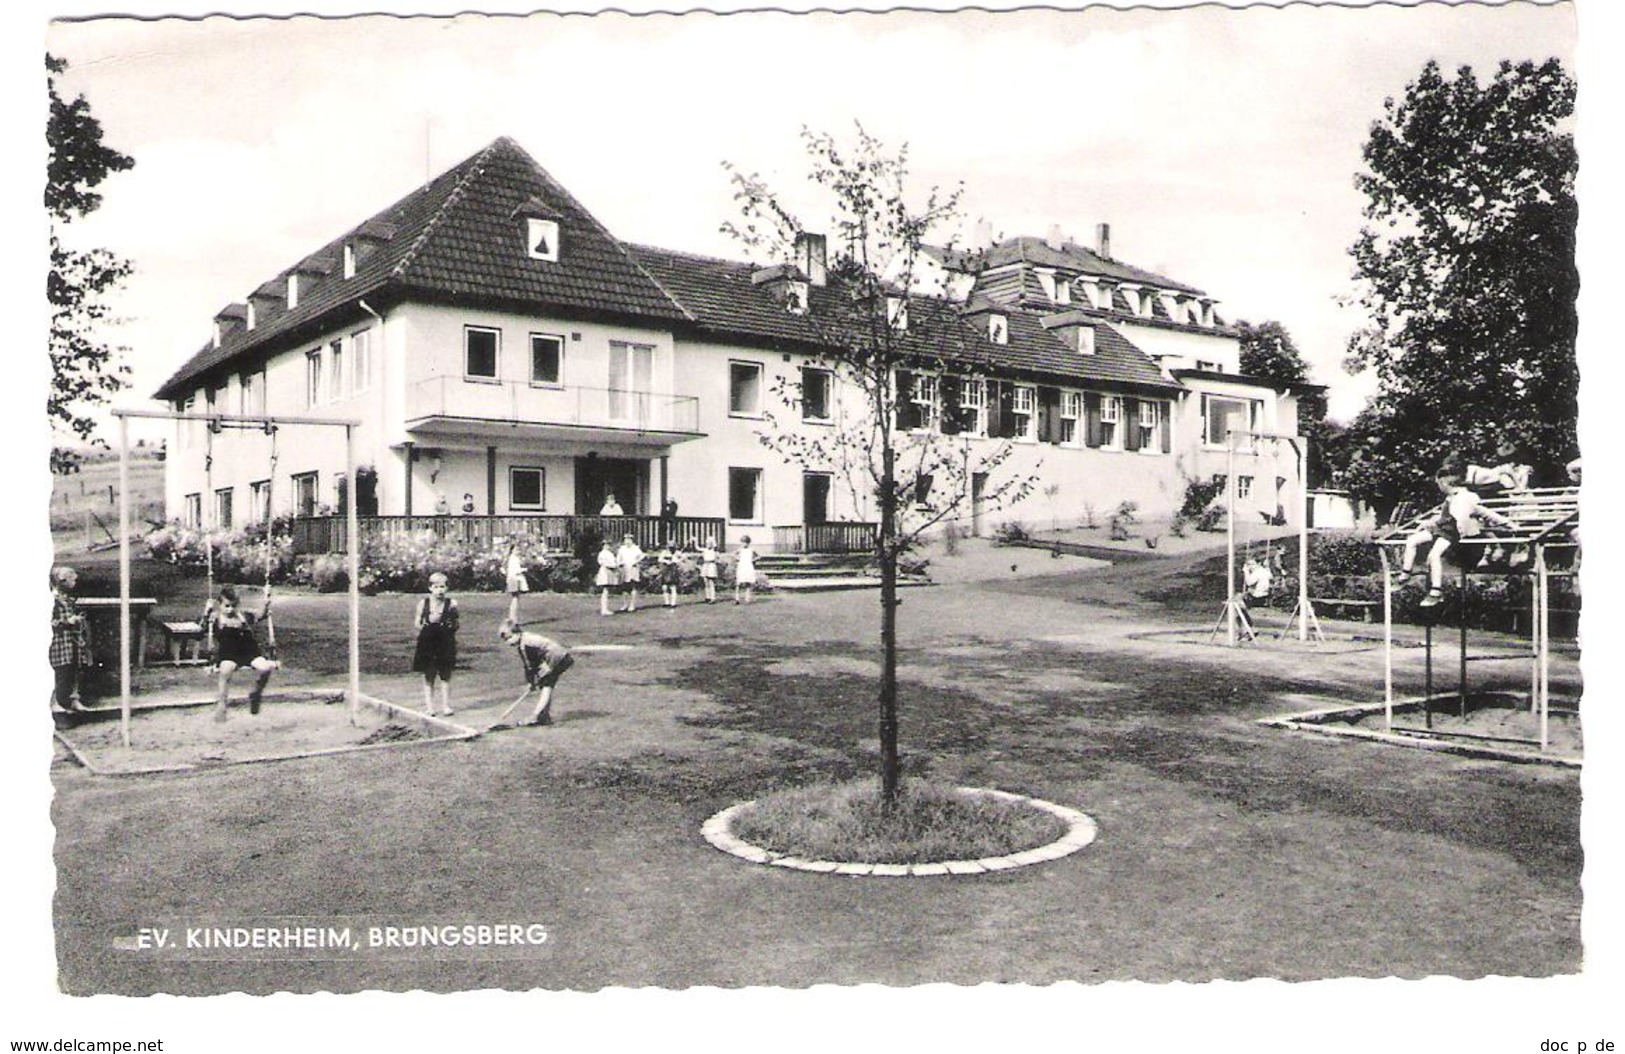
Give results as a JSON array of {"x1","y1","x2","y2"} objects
[{"x1": 293, "y1": 515, "x2": 728, "y2": 554}]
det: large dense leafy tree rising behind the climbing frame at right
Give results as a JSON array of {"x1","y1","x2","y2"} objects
[{"x1": 1347, "y1": 58, "x2": 1580, "y2": 508}]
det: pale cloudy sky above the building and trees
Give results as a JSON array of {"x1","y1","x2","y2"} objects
[{"x1": 47, "y1": 3, "x2": 1576, "y2": 427}]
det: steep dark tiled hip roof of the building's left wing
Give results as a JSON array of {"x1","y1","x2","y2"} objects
[{"x1": 154, "y1": 138, "x2": 684, "y2": 400}]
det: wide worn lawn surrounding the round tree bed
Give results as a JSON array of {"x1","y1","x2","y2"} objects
[{"x1": 52, "y1": 546, "x2": 1583, "y2": 994}]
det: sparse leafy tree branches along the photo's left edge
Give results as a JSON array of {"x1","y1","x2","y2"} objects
[{"x1": 46, "y1": 55, "x2": 135, "y2": 471}]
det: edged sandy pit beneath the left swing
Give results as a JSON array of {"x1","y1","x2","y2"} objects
[{"x1": 57, "y1": 692, "x2": 478, "y2": 776}]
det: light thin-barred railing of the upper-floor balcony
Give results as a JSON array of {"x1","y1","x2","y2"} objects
[{"x1": 406, "y1": 377, "x2": 700, "y2": 432}]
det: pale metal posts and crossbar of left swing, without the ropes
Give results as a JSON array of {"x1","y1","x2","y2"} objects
[{"x1": 112, "y1": 408, "x2": 361, "y2": 747}]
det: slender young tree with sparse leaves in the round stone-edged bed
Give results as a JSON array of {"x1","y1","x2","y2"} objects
[{"x1": 723, "y1": 127, "x2": 1034, "y2": 804}]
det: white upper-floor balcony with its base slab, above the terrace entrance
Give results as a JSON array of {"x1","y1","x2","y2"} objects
[{"x1": 406, "y1": 377, "x2": 700, "y2": 447}]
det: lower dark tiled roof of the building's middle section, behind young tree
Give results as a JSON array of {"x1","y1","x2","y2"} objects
[{"x1": 629, "y1": 245, "x2": 1180, "y2": 388}]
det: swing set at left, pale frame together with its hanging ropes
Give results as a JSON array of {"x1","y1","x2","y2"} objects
[{"x1": 112, "y1": 409, "x2": 361, "y2": 747}]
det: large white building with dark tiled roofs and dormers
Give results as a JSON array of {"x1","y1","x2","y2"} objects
[{"x1": 156, "y1": 138, "x2": 1300, "y2": 547}]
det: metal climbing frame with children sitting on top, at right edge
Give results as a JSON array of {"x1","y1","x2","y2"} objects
[{"x1": 1372, "y1": 487, "x2": 1580, "y2": 752}]
